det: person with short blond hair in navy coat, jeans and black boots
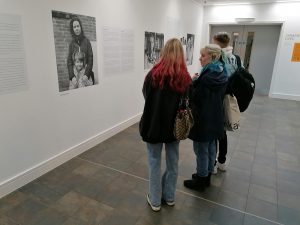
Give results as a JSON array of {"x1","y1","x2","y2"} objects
[{"x1": 184, "y1": 44, "x2": 228, "y2": 191}]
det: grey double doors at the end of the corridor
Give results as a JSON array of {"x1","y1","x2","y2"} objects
[{"x1": 210, "y1": 24, "x2": 281, "y2": 95}]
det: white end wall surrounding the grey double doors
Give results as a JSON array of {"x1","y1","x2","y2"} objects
[{"x1": 202, "y1": 2, "x2": 300, "y2": 100}]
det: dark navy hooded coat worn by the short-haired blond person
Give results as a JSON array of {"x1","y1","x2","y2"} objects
[{"x1": 189, "y1": 61, "x2": 228, "y2": 142}]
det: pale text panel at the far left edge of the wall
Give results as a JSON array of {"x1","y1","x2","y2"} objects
[{"x1": 0, "y1": 14, "x2": 28, "y2": 95}]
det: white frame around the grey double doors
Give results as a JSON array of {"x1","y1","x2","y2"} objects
[{"x1": 206, "y1": 21, "x2": 285, "y2": 97}]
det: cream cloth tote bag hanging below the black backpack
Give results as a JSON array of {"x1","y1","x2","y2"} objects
[{"x1": 224, "y1": 94, "x2": 241, "y2": 131}]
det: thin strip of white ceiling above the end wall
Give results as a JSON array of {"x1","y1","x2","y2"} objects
[{"x1": 195, "y1": 0, "x2": 299, "y2": 5}]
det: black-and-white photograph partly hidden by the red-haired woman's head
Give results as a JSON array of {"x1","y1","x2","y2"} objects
[{"x1": 144, "y1": 31, "x2": 164, "y2": 69}]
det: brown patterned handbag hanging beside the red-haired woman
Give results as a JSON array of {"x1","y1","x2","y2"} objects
[{"x1": 173, "y1": 96, "x2": 194, "y2": 140}]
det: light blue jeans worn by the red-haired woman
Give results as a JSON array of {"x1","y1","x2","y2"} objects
[{"x1": 147, "y1": 141, "x2": 179, "y2": 206}]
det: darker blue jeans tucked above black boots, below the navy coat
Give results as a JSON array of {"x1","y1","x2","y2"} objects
[{"x1": 193, "y1": 140, "x2": 217, "y2": 177}]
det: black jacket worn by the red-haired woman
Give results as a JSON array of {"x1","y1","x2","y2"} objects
[{"x1": 139, "y1": 71, "x2": 180, "y2": 143}]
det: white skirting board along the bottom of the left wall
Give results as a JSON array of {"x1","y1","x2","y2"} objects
[{"x1": 0, "y1": 114, "x2": 141, "y2": 198}]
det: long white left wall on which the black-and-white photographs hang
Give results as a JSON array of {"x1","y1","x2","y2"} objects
[{"x1": 0, "y1": 0, "x2": 203, "y2": 197}]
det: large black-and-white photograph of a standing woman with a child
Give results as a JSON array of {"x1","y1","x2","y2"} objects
[{"x1": 52, "y1": 11, "x2": 98, "y2": 92}]
